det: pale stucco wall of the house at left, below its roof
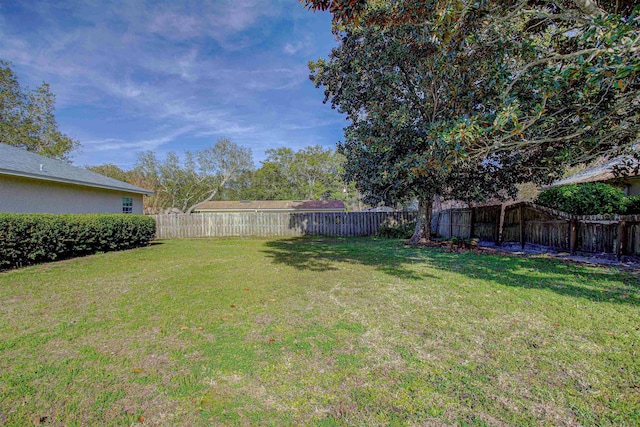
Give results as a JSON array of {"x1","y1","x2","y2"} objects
[{"x1": 0, "y1": 175, "x2": 142, "y2": 214}]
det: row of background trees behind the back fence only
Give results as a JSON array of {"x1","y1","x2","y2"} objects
[{"x1": 87, "y1": 138, "x2": 362, "y2": 213}]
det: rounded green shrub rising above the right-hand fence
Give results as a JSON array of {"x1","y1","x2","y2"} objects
[{"x1": 536, "y1": 182, "x2": 625, "y2": 215}]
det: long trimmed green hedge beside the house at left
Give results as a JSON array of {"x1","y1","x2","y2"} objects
[{"x1": 0, "y1": 213, "x2": 156, "y2": 269}]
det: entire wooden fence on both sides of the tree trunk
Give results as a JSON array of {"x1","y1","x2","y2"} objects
[{"x1": 153, "y1": 208, "x2": 640, "y2": 255}]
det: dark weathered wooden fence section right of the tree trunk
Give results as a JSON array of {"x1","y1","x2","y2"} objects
[{"x1": 432, "y1": 203, "x2": 640, "y2": 256}]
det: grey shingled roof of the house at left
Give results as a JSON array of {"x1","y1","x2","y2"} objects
[{"x1": 0, "y1": 143, "x2": 153, "y2": 194}]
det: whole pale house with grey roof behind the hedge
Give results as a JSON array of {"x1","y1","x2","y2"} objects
[{"x1": 0, "y1": 143, "x2": 153, "y2": 214}]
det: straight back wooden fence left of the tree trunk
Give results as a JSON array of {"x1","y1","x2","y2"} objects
[{"x1": 152, "y1": 212, "x2": 416, "y2": 239}]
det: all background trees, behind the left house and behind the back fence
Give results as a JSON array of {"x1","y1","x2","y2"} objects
[{"x1": 0, "y1": 60, "x2": 363, "y2": 213}]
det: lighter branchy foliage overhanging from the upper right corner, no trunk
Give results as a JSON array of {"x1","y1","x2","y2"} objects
[{"x1": 303, "y1": 0, "x2": 640, "y2": 163}]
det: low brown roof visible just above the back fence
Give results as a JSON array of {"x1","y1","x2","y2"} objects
[{"x1": 194, "y1": 200, "x2": 346, "y2": 211}]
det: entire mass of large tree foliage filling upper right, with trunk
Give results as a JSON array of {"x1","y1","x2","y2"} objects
[{"x1": 307, "y1": 0, "x2": 639, "y2": 241}]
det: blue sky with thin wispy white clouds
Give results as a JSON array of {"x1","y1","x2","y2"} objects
[{"x1": 0, "y1": 0, "x2": 346, "y2": 169}]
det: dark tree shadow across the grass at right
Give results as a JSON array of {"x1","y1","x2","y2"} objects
[{"x1": 265, "y1": 237, "x2": 640, "y2": 305}]
